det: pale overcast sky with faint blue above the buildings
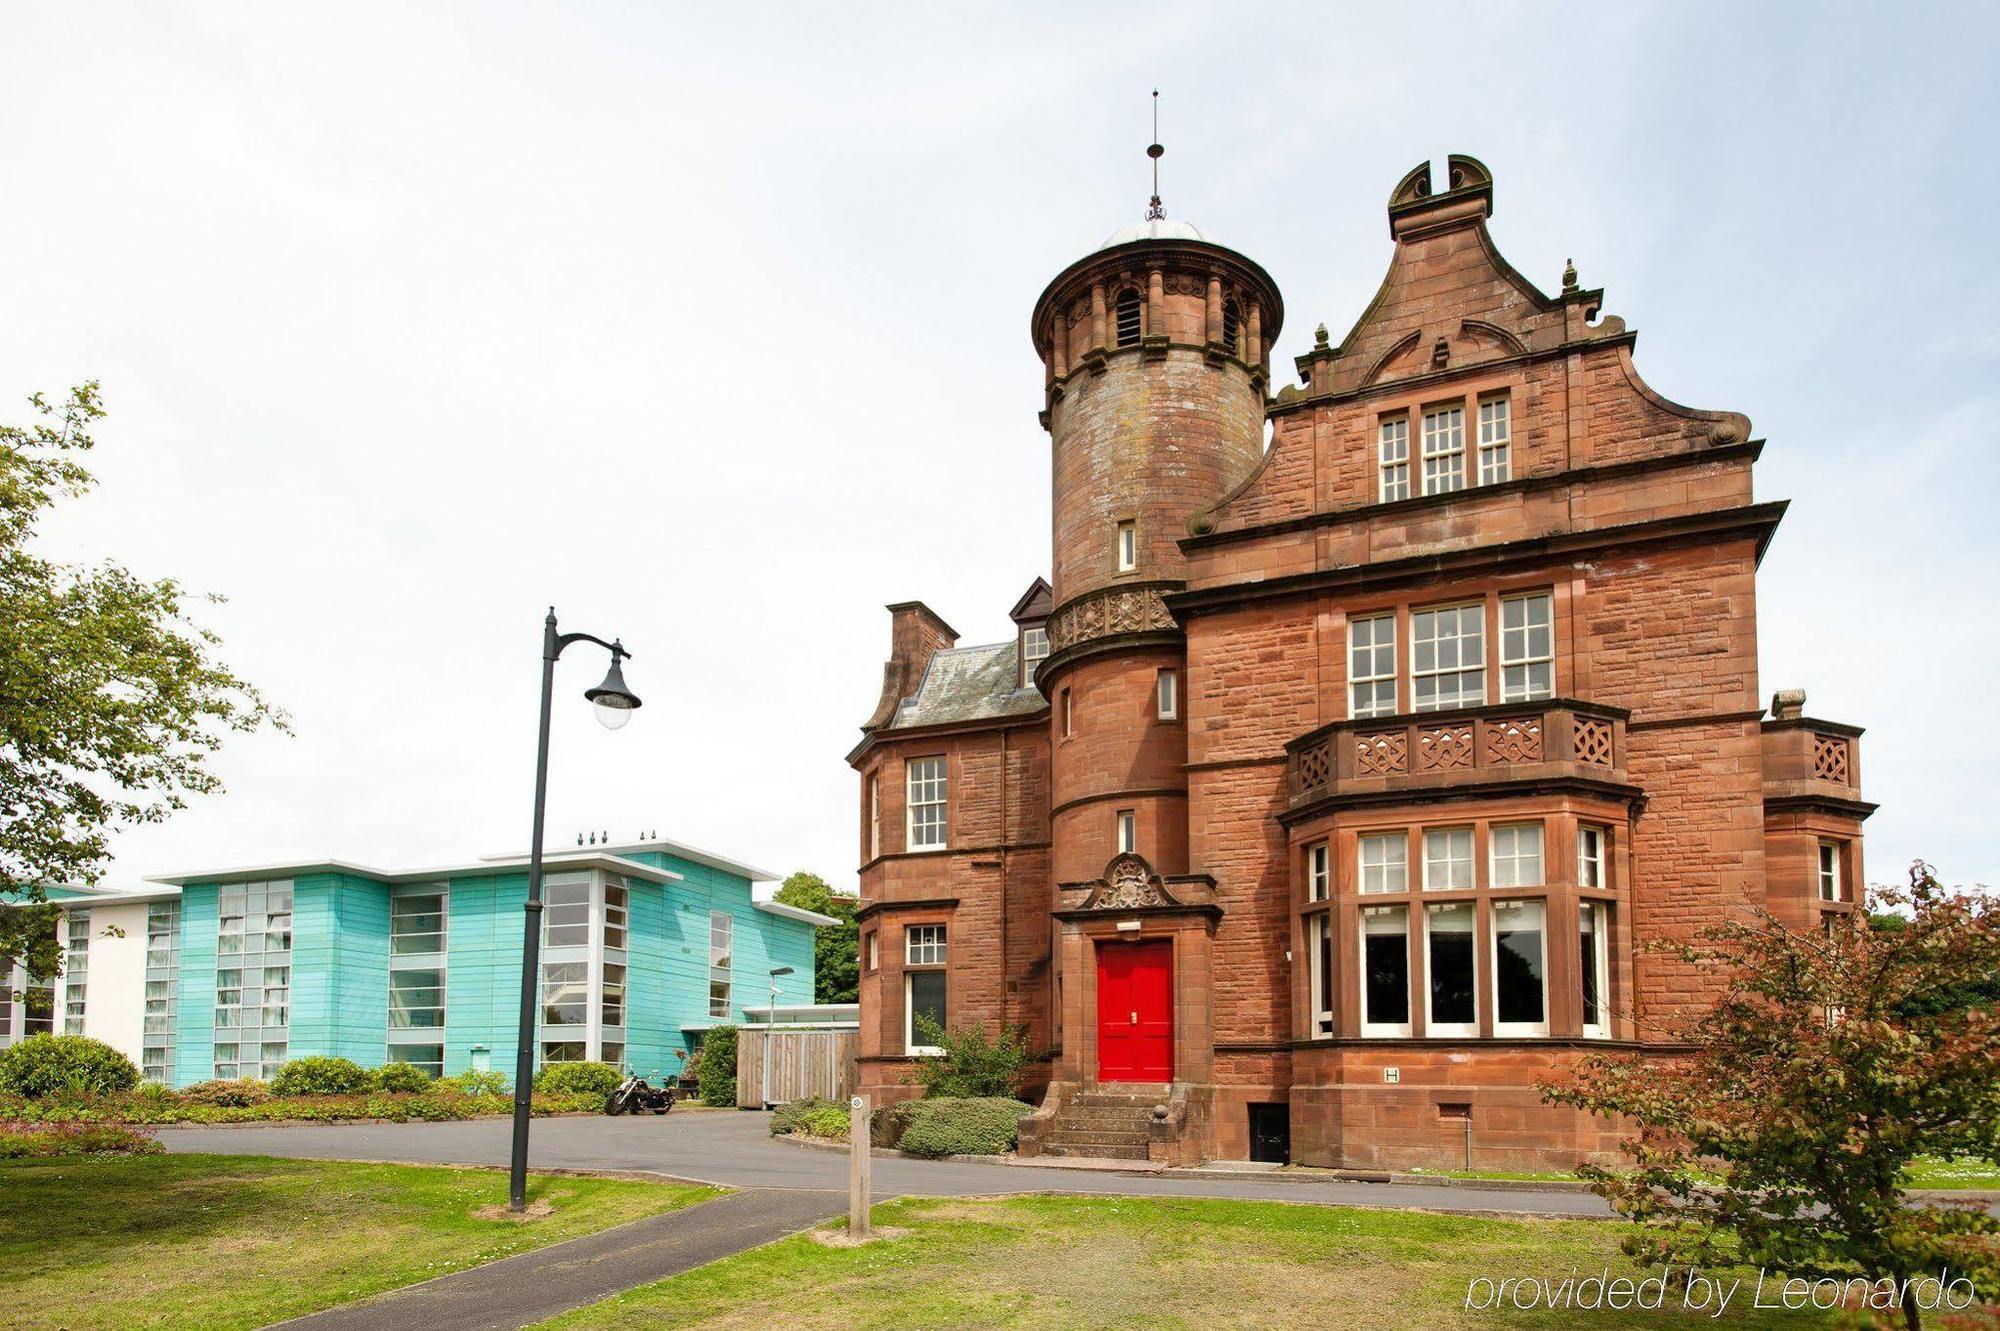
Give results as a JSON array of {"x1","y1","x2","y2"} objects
[{"x1": 0, "y1": 2, "x2": 2000, "y2": 885}]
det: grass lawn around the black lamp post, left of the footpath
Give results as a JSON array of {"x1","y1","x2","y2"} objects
[{"x1": 0, "y1": 1155, "x2": 720, "y2": 1331}]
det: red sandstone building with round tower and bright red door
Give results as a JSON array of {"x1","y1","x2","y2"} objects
[{"x1": 850, "y1": 156, "x2": 1872, "y2": 1167}]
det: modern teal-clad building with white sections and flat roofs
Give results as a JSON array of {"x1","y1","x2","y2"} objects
[{"x1": 0, "y1": 839, "x2": 834, "y2": 1085}]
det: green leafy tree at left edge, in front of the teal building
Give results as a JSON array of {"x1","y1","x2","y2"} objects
[{"x1": 0, "y1": 382, "x2": 286, "y2": 979}]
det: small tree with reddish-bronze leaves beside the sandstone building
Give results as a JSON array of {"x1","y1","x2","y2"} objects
[{"x1": 1544, "y1": 863, "x2": 2000, "y2": 1327}]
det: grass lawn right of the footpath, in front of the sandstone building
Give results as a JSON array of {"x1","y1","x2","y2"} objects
[{"x1": 542, "y1": 1197, "x2": 1832, "y2": 1331}]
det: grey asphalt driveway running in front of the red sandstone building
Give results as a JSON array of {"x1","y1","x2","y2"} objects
[{"x1": 160, "y1": 1111, "x2": 1610, "y2": 1215}]
